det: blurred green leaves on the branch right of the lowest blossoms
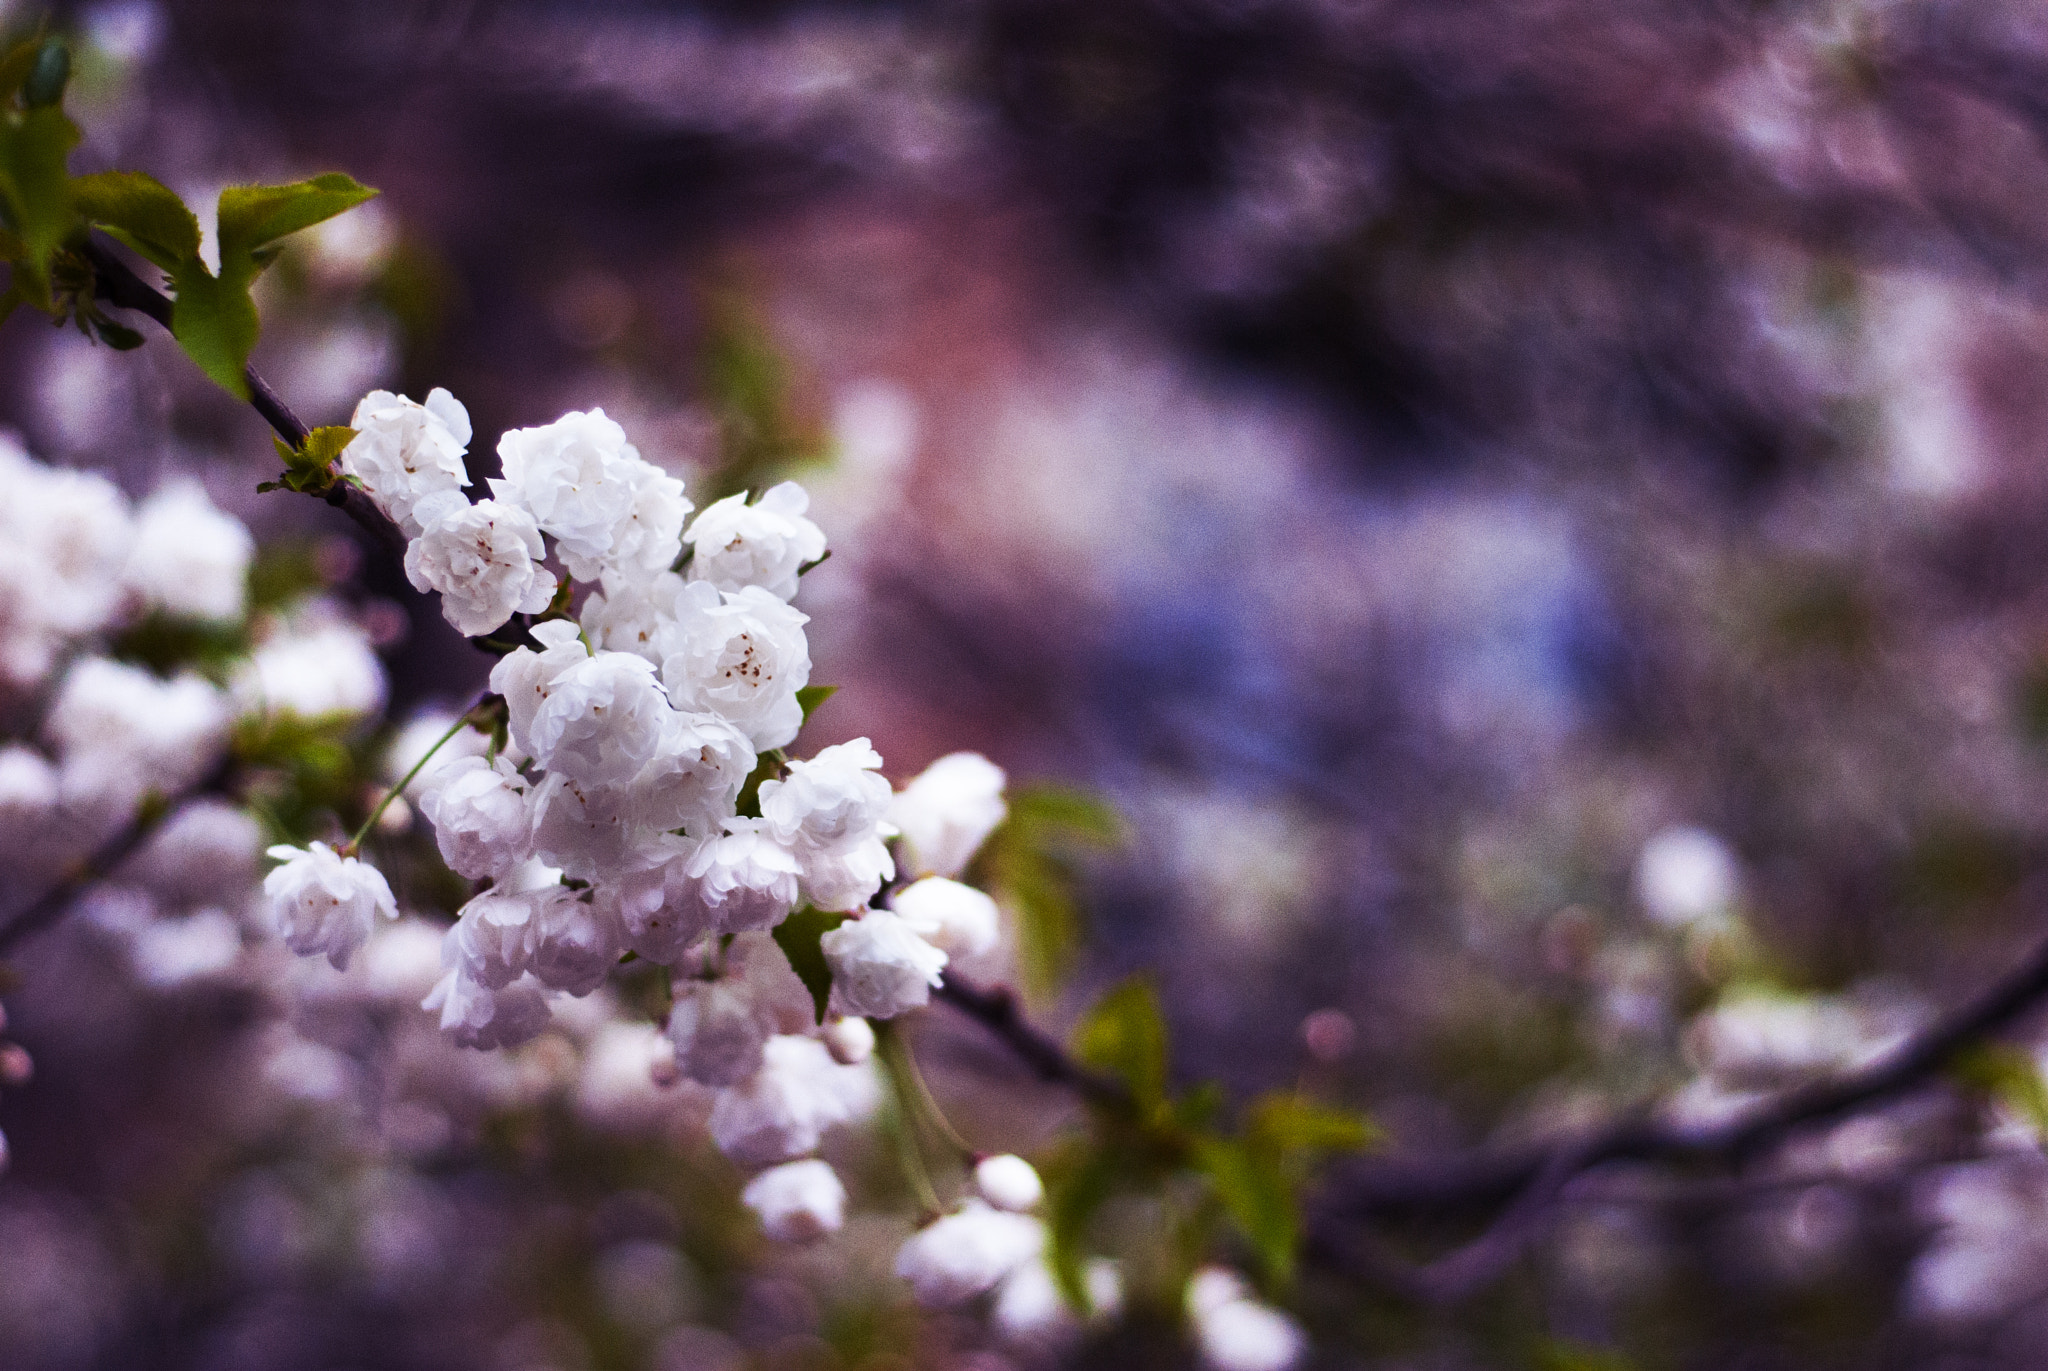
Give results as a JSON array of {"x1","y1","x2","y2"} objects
[{"x1": 1047, "y1": 978, "x2": 1376, "y2": 1307}]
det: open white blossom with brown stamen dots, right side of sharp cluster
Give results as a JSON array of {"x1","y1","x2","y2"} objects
[{"x1": 662, "y1": 580, "x2": 811, "y2": 752}]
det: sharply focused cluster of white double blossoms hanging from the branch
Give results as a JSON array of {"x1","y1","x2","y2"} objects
[{"x1": 264, "y1": 389, "x2": 1024, "y2": 1240}]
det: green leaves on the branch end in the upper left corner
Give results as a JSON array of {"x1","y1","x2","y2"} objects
[{"x1": 0, "y1": 37, "x2": 377, "y2": 401}]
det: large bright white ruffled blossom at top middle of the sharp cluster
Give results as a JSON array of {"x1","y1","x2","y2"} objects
[{"x1": 492, "y1": 410, "x2": 643, "y2": 580}]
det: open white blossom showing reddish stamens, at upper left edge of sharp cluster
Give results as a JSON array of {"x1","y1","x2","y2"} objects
[{"x1": 406, "y1": 490, "x2": 555, "y2": 637}]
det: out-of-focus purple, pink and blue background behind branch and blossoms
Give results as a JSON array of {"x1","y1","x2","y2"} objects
[{"x1": 12, "y1": 0, "x2": 2048, "y2": 1371}]
